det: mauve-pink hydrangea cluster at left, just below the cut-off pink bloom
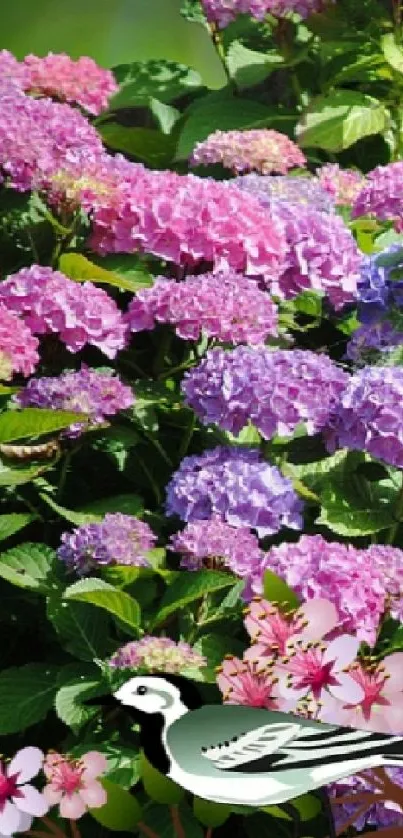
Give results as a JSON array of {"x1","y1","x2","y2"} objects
[{"x1": 15, "y1": 366, "x2": 134, "y2": 437}]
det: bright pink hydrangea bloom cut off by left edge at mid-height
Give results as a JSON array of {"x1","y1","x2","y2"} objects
[{"x1": 0, "y1": 303, "x2": 39, "y2": 381}]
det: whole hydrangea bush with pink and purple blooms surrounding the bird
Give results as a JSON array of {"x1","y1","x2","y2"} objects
[{"x1": 0, "y1": 0, "x2": 403, "y2": 838}]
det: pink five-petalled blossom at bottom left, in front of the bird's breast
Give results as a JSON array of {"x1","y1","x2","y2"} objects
[{"x1": 43, "y1": 751, "x2": 107, "y2": 820}]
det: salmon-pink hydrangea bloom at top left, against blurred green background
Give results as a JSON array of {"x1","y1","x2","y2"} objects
[{"x1": 23, "y1": 52, "x2": 118, "y2": 115}]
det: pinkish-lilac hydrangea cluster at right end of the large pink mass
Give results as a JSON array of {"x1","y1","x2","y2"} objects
[{"x1": 271, "y1": 202, "x2": 363, "y2": 310}]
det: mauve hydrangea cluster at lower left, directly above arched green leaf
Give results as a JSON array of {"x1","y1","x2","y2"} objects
[{"x1": 57, "y1": 512, "x2": 156, "y2": 576}]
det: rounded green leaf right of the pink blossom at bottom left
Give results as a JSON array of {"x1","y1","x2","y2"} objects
[{"x1": 89, "y1": 777, "x2": 143, "y2": 832}]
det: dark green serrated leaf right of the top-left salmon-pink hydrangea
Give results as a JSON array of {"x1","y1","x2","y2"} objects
[{"x1": 109, "y1": 58, "x2": 203, "y2": 110}]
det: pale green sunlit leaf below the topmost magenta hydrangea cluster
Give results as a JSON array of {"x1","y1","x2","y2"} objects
[{"x1": 227, "y1": 41, "x2": 284, "y2": 90}]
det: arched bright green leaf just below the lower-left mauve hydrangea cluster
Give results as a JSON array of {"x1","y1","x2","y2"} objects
[{"x1": 64, "y1": 578, "x2": 140, "y2": 633}]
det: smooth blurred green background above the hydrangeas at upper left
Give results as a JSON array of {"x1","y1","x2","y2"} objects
[{"x1": 0, "y1": 0, "x2": 225, "y2": 88}]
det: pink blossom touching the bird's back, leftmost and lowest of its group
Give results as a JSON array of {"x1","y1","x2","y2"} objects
[{"x1": 217, "y1": 655, "x2": 279, "y2": 710}]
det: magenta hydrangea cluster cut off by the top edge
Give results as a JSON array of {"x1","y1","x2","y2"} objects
[{"x1": 202, "y1": 0, "x2": 332, "y2": 29}]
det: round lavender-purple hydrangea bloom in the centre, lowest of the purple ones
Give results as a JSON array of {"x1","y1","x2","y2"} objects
[{"x1": 166, "y1": 446, "x2": 302, "y2": 536}]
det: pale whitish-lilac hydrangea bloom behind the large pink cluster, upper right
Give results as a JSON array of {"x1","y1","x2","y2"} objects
[{"x1": 231, "y1": 173, "x2": 334, "y2": 213}]
